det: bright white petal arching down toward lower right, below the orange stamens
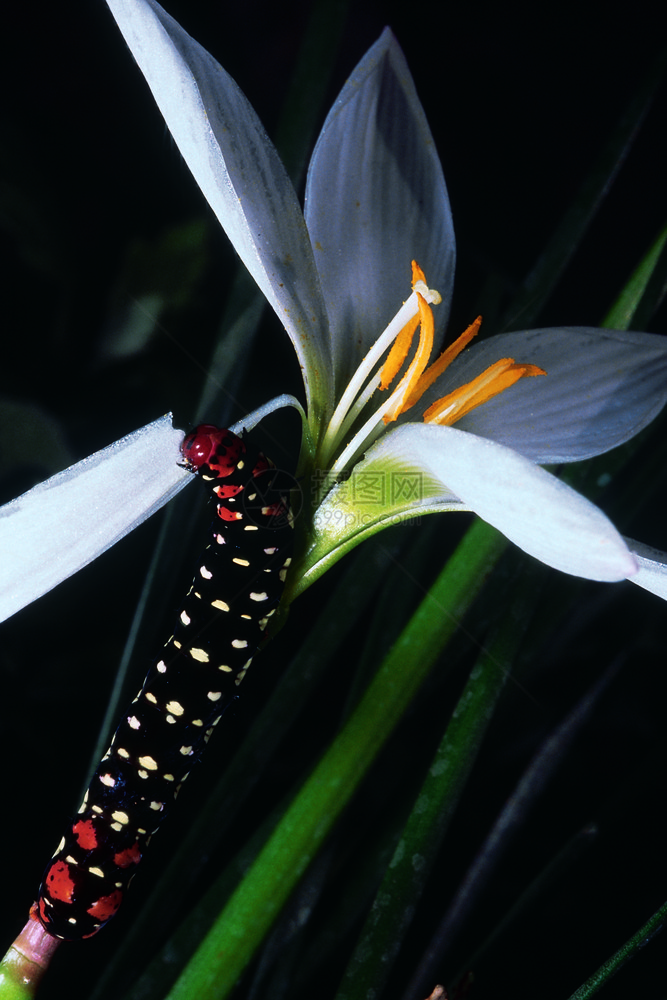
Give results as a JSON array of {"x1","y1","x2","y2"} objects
[{"x1": 362, "y1": 424, "x2": 637, "y2": 581}]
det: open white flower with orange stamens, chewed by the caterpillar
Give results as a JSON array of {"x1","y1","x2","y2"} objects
[{"x1": 0, "y1": 0, "x2": 667, "y2": 614}]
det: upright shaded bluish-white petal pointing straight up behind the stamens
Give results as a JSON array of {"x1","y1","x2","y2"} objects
[{"x1": 306, "y1": 29, "x2": 455, "y2": 388}]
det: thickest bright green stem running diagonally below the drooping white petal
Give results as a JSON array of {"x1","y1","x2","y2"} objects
[{"x1": 169, "y1": 521, "x2": 507, "y2": 1000}]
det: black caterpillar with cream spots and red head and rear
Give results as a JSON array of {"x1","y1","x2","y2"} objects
[{"x1": 33, "y1": 424, "x2": 292, "y2": 941}]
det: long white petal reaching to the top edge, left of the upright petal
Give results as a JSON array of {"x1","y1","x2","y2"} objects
[{"x1": 107, "y1": 0, "x2": 331, "y2": 420}]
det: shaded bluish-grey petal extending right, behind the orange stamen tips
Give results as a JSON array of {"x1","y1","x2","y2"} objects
[{"x1": 438, "y1": 327, "x2": 667, "y2": 463}]
